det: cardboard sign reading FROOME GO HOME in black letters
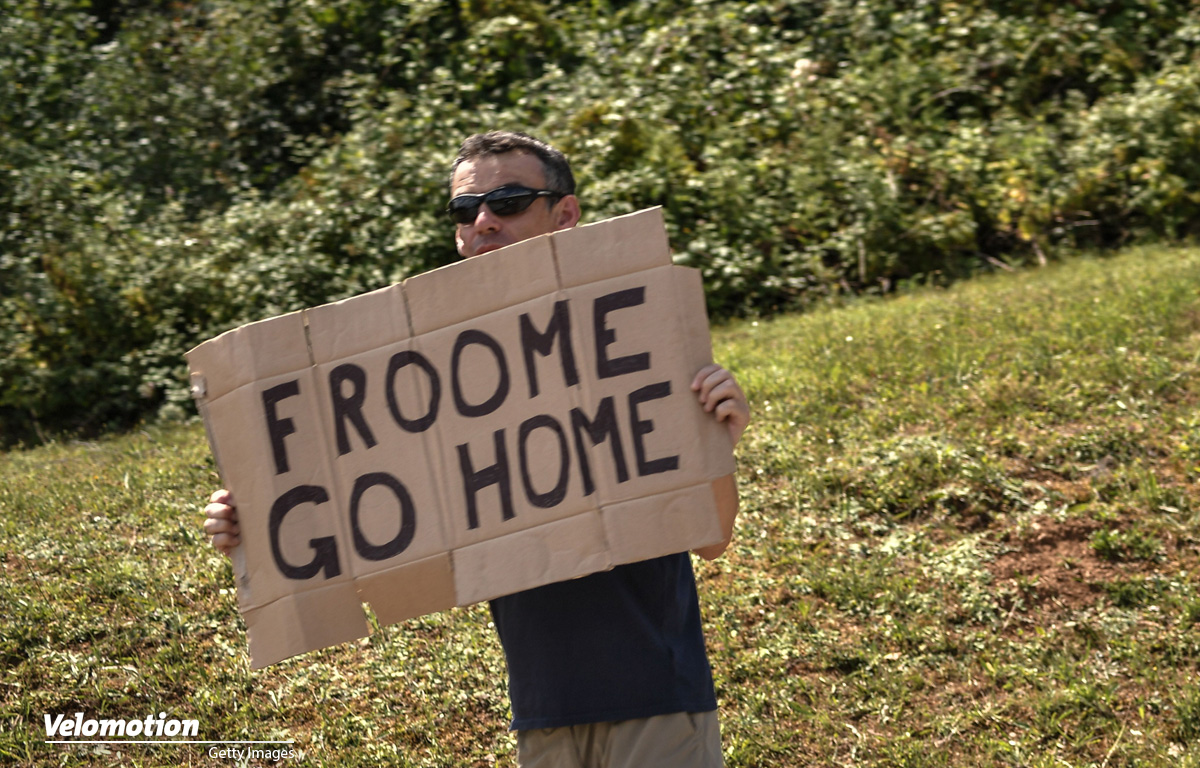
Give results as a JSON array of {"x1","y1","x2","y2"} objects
[{"x1": 187, "y1": 209, "x2": 734, "y2": 667}]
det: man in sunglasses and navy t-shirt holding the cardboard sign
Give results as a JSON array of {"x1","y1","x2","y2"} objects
[{"x1": 204, "y1": 132, "x2": 750, "y2": 768}]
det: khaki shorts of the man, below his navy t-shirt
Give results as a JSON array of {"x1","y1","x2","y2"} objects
[{"x1": 517, "y1": 712, "x2": 725, "y2": 768}]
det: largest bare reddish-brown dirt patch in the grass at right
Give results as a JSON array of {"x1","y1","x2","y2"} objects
[{"x1": 989, "y1": 520, "x2": 1127, "y2": 611}]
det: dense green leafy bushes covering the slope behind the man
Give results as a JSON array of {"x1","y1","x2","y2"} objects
[{"x1": 0, "y1": 0, "x2": 1200, "y2": 443}]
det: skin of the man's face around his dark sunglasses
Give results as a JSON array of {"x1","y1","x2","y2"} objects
[{"x1": 450, "y1": 151, "x2": 580, "y2": 258}]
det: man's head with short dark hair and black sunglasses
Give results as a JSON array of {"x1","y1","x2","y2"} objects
[{"x1": 450, "y1": 131, "x2": 580, "y2": 258}]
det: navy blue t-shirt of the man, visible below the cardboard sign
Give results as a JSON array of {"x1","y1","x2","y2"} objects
[{"x1": 491, "y1": 552, "x2": 716, "y2": 731}]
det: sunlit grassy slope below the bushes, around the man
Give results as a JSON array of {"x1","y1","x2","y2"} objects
[{"x1": 0, "y1": 248, "x2": 1200, "y2": 768}]
